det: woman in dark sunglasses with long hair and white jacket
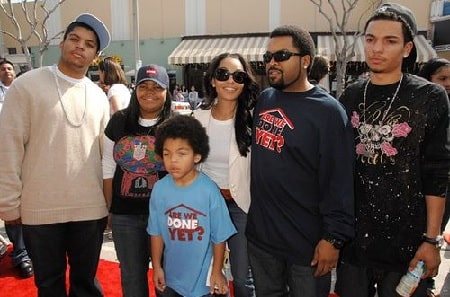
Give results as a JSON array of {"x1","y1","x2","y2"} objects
[{"x1": 194, "y1": 53, "x2": 259, "y2": 297}]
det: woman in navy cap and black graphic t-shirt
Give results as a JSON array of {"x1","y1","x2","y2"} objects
[{"x1": 103, "y1": 65, "x2": 171, "y2": 297}]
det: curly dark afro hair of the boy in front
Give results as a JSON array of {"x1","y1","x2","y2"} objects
[{"x1": 155, "y1": 115, "x2": 209, "y2": 162}]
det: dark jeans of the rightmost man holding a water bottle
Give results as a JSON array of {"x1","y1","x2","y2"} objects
[{"x1": 335, "y1": 262, "x2": 429, "y2": 297}]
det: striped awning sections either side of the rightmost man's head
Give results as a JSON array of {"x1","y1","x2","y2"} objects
[{"x1": 317, "y1": 35, "x2": 436, "y2": 63}]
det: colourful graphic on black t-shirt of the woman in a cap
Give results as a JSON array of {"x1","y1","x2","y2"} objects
[{"x1": 113, "y1": 135, "x2": 164, "y2": 198}]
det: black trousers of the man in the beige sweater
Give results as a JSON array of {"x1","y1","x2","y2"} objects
[{"x1": 22, "y1": 217, "x2": 106, "y2": 297}]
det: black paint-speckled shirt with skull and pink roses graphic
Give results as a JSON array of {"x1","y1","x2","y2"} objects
[{"x1": 339, "y1": 74, "x2": 450, "y2": 272}]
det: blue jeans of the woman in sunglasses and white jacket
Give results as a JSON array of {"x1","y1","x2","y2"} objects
[{"x1": 227, "y1": 200, "x2": 255, "y2": 297}]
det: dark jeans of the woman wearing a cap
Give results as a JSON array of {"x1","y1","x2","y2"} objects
[{"x1": 111, "y1": 214, "x2": 150, "y2": 297}]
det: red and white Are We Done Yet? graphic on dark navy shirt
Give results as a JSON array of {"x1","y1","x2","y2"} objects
[{"x1": 255, "y1": 108, "x2": 294, "y2": 153}]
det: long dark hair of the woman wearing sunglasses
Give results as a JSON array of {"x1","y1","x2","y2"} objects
[{"x1": 203, "y1": 53, "x2": 259, "y2": 157}]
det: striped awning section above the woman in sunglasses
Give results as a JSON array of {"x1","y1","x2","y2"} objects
[{"x1": 168, "y1": 36, "x2": 269, "y2": 65}]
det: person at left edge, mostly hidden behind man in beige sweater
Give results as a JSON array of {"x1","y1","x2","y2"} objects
[{"x1": 0, "y1": 59, "x2": 33, "y2": 278}]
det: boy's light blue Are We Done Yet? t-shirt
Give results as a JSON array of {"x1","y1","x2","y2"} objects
[{"x1": 147, "y1": 173, "x2": 236, "y2": 297}]
